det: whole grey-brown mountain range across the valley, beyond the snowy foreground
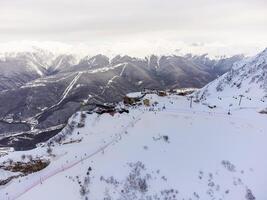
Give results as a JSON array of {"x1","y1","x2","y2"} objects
[{"x1": 0, "y1": 49, "x2": 243, "y2": 149}]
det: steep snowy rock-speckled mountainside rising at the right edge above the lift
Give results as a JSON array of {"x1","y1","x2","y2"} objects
[{"x1": 196, "y1": 49, "x2": 267, "y2": 109}]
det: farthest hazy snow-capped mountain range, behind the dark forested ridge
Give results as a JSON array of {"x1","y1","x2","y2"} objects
[{"x1": 0, "y1": 48, "x2": 242, "y2": 91}]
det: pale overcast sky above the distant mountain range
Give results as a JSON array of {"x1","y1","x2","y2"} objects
[{"x1": 0, "y1": 0, "x2": 267, "y2": 55}]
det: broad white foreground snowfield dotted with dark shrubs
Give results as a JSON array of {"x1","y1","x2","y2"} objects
[{"x1": 0, "y1": 92, "x2": 267, "y2": 200}]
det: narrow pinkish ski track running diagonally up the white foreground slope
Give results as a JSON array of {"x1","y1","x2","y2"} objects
[{"x1": 6, "y1": 113, "x2": 143, "y2": 200}]
